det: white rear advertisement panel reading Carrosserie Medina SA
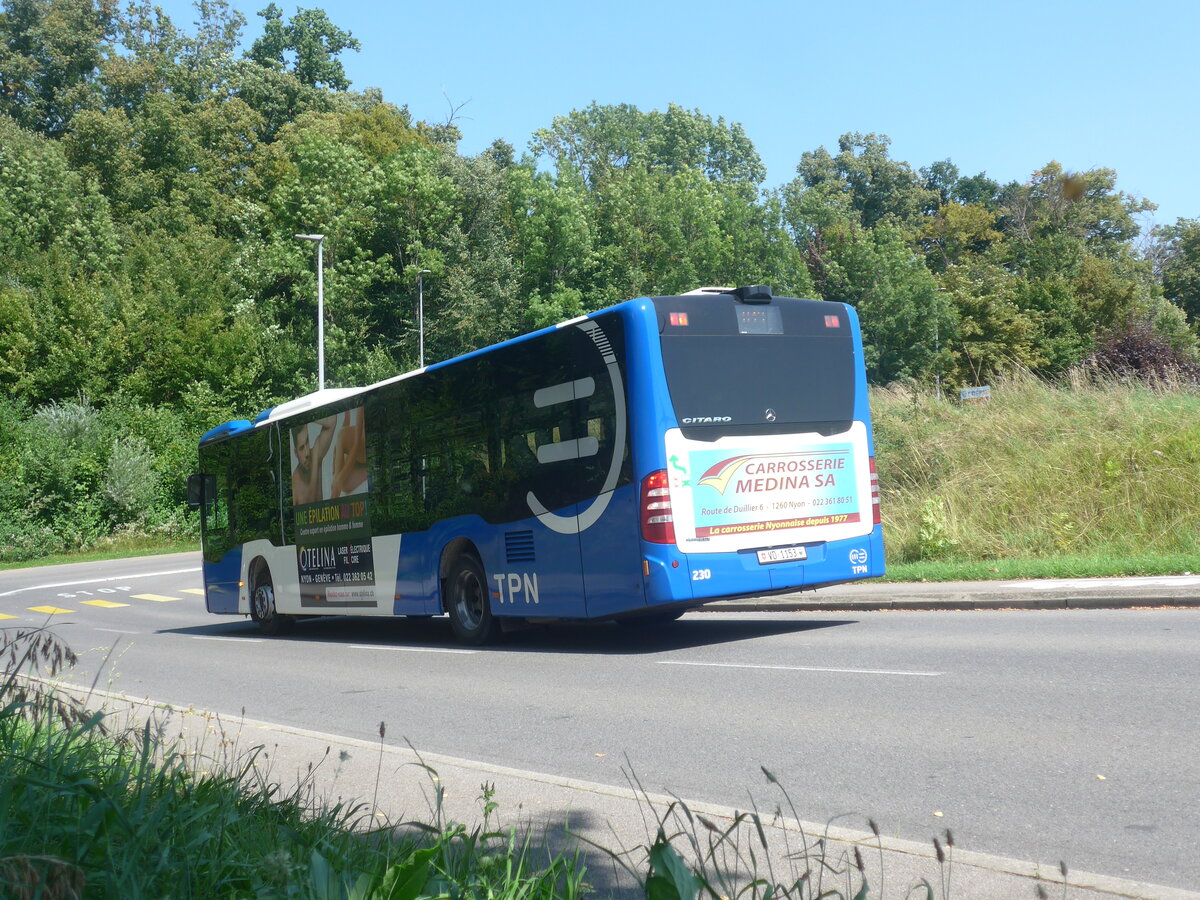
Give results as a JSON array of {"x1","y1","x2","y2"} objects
[{"x1": 667, "y1": 433, "x2": 871, "y2": 550}]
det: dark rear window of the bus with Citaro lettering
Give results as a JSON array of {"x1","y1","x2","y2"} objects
[{"x1": 654, "y1": 294, "x2": 854, "y2": 439}]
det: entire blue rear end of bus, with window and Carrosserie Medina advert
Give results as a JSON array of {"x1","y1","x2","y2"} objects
[{"x1": 634, "y1": 292, "x2": 883, "y2": 605}]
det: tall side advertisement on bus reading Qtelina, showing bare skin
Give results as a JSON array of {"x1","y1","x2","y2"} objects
[{"x1": 289, "y1": 407, "x2": 374, "y2": 607}]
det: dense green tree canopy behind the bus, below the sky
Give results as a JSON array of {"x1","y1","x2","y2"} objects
[{"x1": 0, "y1": 0, "x2": 1200, "y2": 427}]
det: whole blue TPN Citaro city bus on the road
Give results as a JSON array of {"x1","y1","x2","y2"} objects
[{"x1": 188, "y1": 286, "x2": 883, "y2": 644}]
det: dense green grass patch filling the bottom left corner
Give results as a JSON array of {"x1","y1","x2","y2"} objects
[{"x1": 0, "y1": 631, "x2": 583, "y2": 900}]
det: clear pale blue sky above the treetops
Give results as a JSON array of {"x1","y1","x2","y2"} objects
[{"x1": 162, "y1": 0, "x2": 1200, "y2": 230}]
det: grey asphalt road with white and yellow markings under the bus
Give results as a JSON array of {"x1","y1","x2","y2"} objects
[{"x1": 0, "y1": 554, "x2": 1200, "y2": 889}]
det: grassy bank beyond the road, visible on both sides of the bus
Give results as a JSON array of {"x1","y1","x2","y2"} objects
[{"x1": 0, "y1": 376, "x2": 1200, "y2": 581}]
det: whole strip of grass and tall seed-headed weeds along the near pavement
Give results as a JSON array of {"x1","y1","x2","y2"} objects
[{"x1": 0, "y1": 630, "x2": 1067, "y2": 900}]
